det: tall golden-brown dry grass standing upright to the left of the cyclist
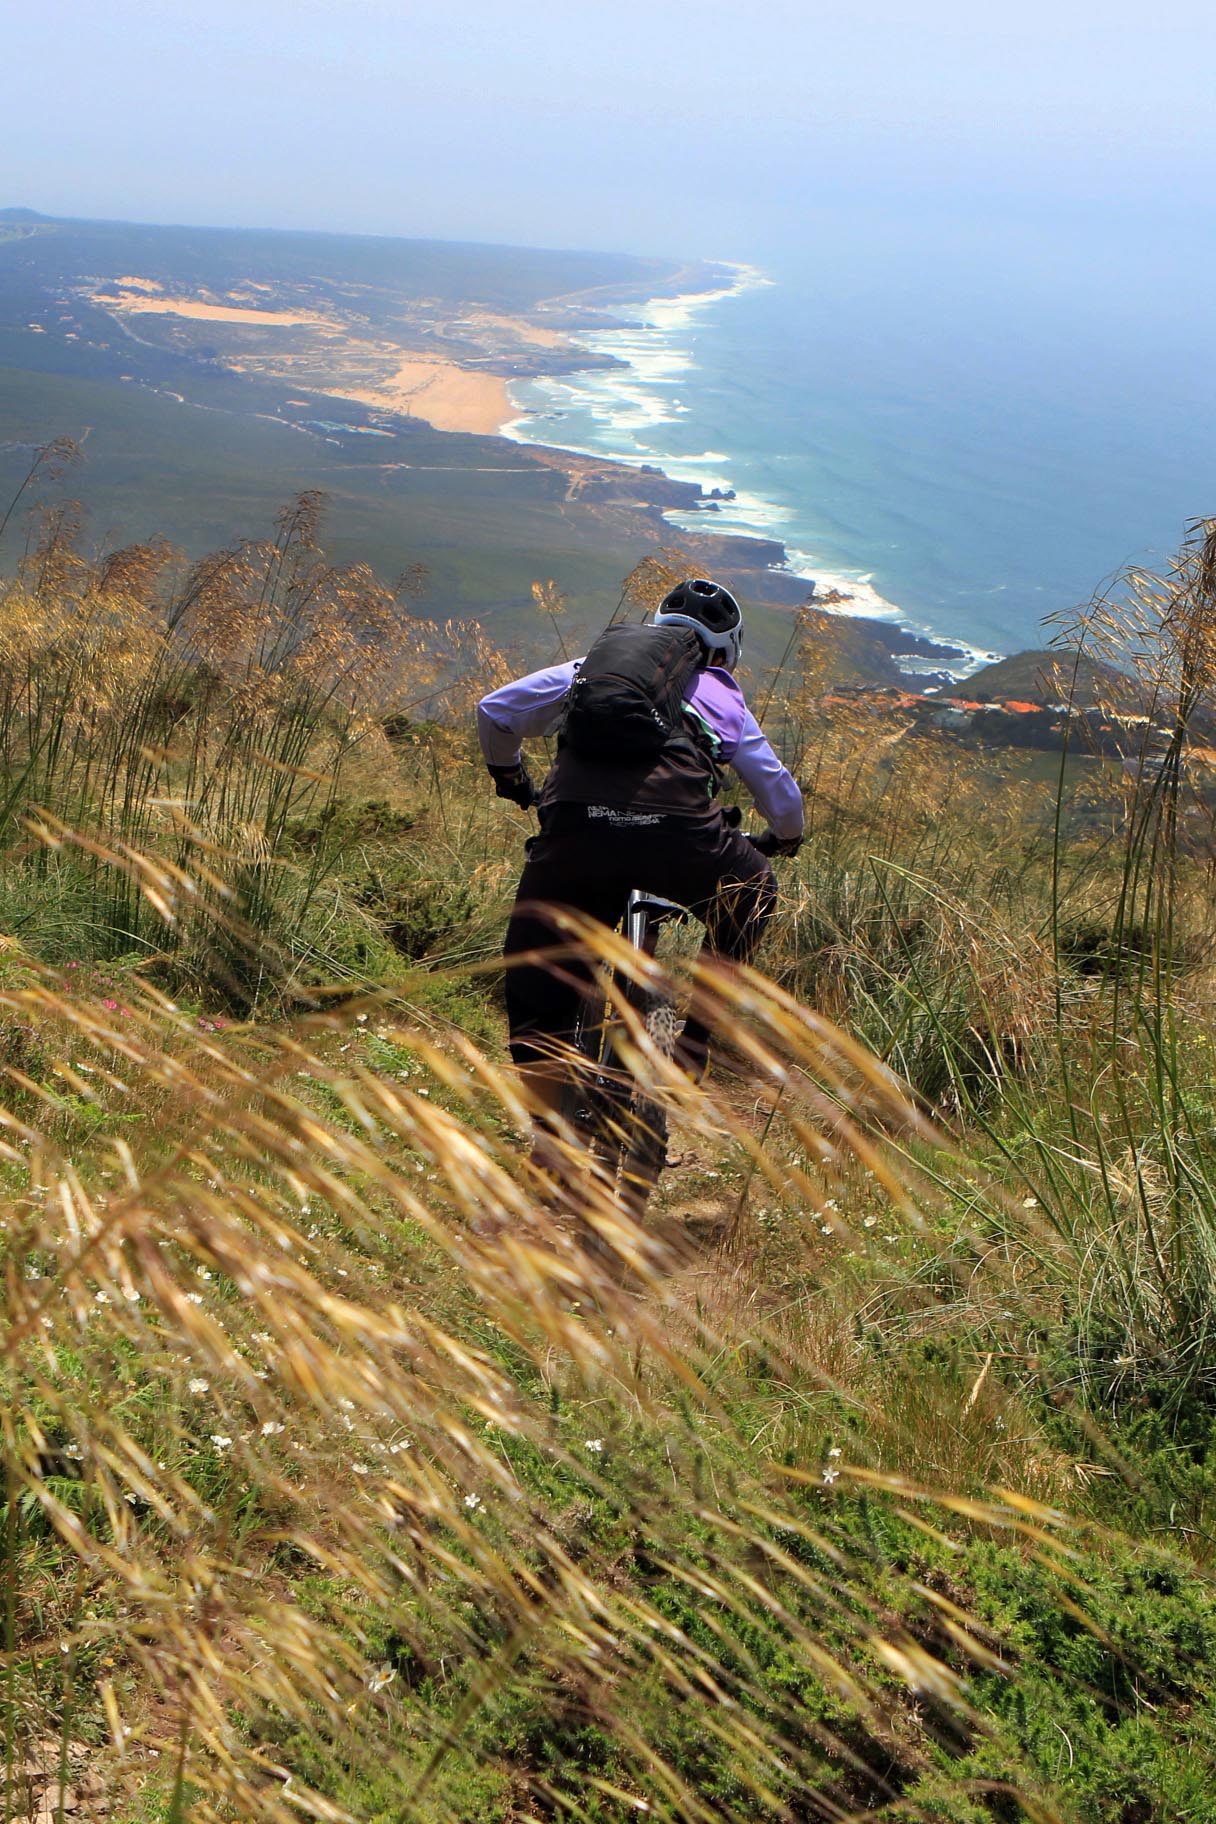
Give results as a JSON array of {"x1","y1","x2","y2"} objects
[{"x1": 0, "y1": 494, "x2": 510, "y2": 1010}]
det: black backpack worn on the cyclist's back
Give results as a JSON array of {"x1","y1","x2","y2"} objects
[{"x1": 558, "y1": 624, "x2": 706, "y2": 766}]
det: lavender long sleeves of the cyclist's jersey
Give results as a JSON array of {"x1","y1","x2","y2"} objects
[{"x1": 478, "y1": 658, "x2": 802, "y2": 837}]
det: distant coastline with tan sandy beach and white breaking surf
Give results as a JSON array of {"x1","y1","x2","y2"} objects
[{"x1": 73, "y1": 228, "x2": 999, "y2": 689}]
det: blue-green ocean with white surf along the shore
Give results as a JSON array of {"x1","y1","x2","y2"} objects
[{"x1": 509, "y1": 208, "x2": 1216, "y2": 675}]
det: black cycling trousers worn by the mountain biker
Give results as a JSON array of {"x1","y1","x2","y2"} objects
[{"x1": 503, "y1": 804, "x2": 777, "y2": 1065}]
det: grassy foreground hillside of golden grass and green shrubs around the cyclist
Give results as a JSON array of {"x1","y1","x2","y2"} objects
[{"x1": 0, "y1": 498, "x2": 1216, "y2": 1824}]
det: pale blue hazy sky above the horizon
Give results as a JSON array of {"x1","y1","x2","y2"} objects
[{"x1": 0, "y1": 0, "x2": 1216, "y2": 259}]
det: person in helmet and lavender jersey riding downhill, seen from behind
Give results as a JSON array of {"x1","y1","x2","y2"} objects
[{"x1": 478, "y1": 576, "x2": 802, "y2": 1138}]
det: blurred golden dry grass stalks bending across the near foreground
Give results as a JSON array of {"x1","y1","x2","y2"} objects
[{"x1": 0, "y1": 919, "x2": 1093, "y2": 1820}]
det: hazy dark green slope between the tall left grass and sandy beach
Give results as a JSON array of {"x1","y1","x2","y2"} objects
[{"x1": 0, "y1": 368, "x2": 659, "y2": 637}]
